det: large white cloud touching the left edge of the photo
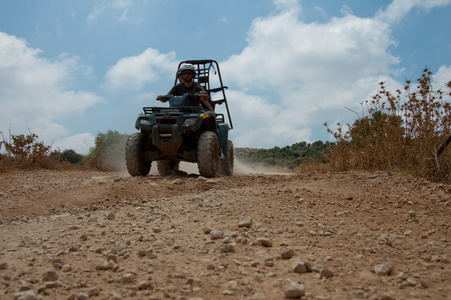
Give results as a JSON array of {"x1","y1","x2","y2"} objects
[{"x1": 0, "y1": 32, "x2": 104, "y2": 150}]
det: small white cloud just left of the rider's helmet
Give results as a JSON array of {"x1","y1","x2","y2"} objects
[{"x1": 105, "y1": 48, "x2": 177, "y2": 90}]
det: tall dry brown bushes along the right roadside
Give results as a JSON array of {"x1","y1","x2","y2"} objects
[{"x1": 325, "y1": 69, "x2": 451, "y2": 182}]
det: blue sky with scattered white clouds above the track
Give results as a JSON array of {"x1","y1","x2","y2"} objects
[{"x1": 0, "y1": 0, "x2": 451, "y2": 154}]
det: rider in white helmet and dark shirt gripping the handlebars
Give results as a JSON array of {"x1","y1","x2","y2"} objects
[{"x1": 157, "y1": 64, "x2": 214, "y2": 112}]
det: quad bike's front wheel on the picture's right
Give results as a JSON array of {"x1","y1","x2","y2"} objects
[{"x1": 197, "y1": 131, "x2": 219, "y2": 177}]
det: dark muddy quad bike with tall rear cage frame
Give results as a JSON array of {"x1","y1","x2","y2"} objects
[{"x1": 125, "y1": 59, "x2": 234, "y2": 177}]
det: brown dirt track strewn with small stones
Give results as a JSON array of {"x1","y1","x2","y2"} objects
[{"x1": 0, "y1": 164, "x2": 451, "y2": 299}]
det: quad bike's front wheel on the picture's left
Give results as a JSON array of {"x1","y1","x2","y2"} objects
[{"x1": 125, "y1": 132, "x2": 151, "y2": 176}]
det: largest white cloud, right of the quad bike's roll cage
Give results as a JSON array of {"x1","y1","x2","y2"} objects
[{"x1": 221, "y1": 2, "x2": 399, "y2": 145}]
